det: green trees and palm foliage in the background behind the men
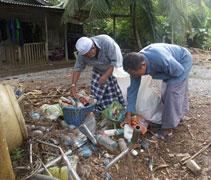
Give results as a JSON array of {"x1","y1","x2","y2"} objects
[{"x1": 63, "y1": 0, "x2": 211, "y2": 48}]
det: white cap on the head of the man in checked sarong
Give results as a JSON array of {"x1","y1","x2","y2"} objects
[{"x1": 75, "y1": 37, "x2": 93, "y2": 55}]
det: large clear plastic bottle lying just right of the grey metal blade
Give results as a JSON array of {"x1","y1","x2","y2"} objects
[{"x1": 96, "y1": 134, "x2": 118, "y2": 151}]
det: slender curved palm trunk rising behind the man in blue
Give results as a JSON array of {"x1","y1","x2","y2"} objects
[{"x1": 130, "y1": 0, "x2": 142, "y2": 50}]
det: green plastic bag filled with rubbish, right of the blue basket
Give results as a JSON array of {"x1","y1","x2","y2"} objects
[{"x1": 102, "y1": 101, "x2": 125, "y2": 123}]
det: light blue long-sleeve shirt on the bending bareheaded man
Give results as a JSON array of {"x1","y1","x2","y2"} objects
[{"x1": 127, "y1": 43, "x2": 192, "y2": 112}]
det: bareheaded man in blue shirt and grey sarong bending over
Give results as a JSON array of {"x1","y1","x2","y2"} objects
[{"x1": 121, "y1": 43, "x2": 192, "y2": 140}]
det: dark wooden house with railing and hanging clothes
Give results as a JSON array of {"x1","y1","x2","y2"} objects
[{"x1": 0, "y1": 0, "x2": 83, "y2": 70}]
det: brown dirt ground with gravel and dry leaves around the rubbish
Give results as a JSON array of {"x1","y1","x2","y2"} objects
[{"x1": 0, "y1": 49, "x2": 211, "y2": 180}]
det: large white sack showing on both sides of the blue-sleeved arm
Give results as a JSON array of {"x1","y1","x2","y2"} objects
[{"x1": 113, "y1": 68, "x2": 163, "y2": 124}]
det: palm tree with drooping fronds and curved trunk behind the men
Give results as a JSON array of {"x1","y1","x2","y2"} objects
[{"x1": 63, "y1": 0, "x2": 155, "y2": 49}]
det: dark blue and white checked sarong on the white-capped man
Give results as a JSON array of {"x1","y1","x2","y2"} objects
[{"x1": 91, "y1": 71, "x2": 126, "y2": 113}]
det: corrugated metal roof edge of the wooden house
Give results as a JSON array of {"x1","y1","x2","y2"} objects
[{"x1": 0, "y1": 0, "x2": 64, "y2": 10}]
